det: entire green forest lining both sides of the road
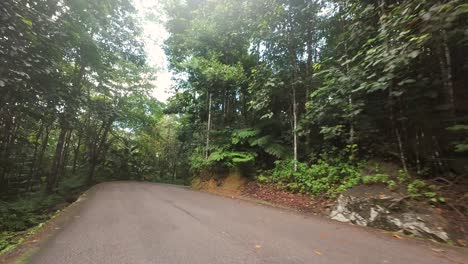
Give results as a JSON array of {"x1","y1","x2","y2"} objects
[{"x1": 0, "y1": 0, "x2": 468, "y2": 250}]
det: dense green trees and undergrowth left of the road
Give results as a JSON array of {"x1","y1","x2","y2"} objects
[{"x1": 0, "y1": 0, "x2": 188, "y2": 251}]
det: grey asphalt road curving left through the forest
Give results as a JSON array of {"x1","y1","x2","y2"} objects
[{"x1": 29, "y1": 182, "x2": 468, "y2": 264}]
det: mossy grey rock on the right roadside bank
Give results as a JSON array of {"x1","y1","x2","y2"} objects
[{"x1": 330, "y1": 185, "x2": 451, "y2": 242}]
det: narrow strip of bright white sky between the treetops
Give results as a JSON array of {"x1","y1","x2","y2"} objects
[{"x1": 134, "y1": 0, "x2": 173, "y2": 102}]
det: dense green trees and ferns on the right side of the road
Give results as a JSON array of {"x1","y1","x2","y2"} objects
[{"x1": 165, "y1": 0, "x2": 468, "y2": 196}]
